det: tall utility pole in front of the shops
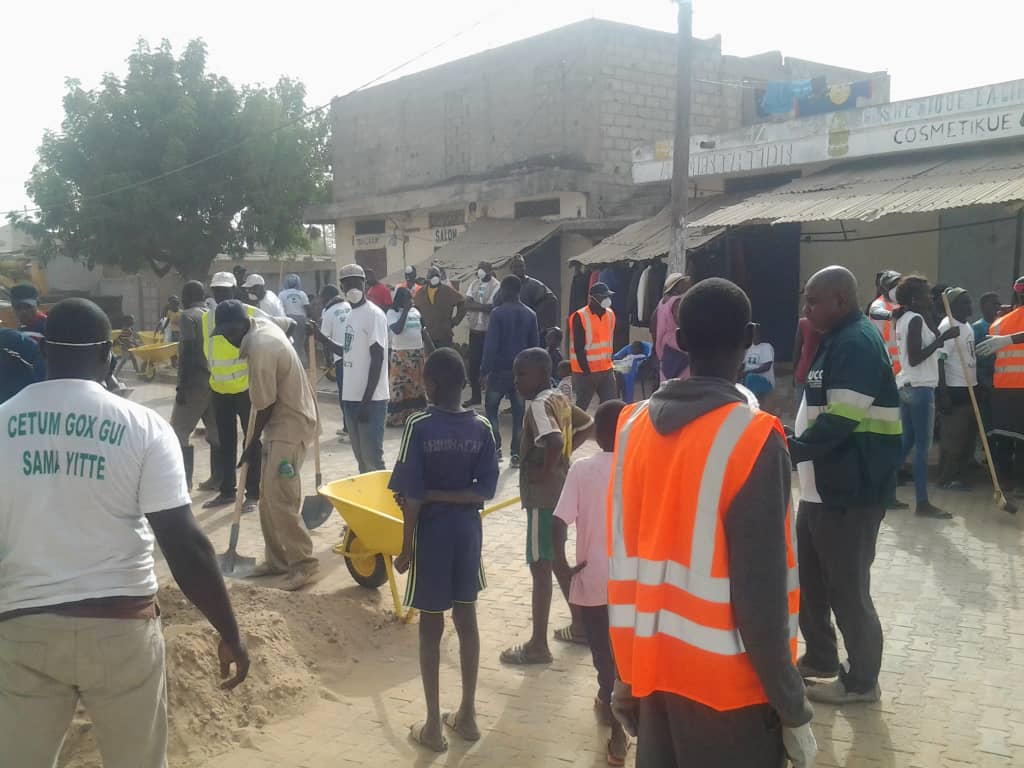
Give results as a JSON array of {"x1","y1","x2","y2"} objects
[{"x1": 669, "y1": 0, "x2": 693, "y2": 272}]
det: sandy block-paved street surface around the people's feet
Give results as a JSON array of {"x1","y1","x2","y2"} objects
[{"x1": 125, "y1": 384, "x2": 1024, "y2": 768}]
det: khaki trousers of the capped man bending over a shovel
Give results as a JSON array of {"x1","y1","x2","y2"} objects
[{"x1": 259, "y1": 440, "x2": 319, "y2": 572}]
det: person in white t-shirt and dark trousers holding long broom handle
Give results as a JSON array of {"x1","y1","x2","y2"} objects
[{"x1": 936, "y1": 288, "x2": 978, "y2": 490}]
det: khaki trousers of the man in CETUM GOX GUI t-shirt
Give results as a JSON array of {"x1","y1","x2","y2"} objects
[{"x1": 0, "y1": 613, "x2": 167, "y2": 768}]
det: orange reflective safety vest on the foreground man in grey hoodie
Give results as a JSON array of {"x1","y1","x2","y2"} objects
[{"x1": 608, "y1": 402, "x2": 800, "y2": 711}]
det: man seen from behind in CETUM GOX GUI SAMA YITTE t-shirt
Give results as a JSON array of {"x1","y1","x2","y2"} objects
[{"x1": 0, "y1": 299, "x2": 249, "y2": 768}]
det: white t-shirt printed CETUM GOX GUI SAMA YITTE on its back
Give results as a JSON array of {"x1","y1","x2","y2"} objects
[{"x1": 0, "y1": 379, "x2": 190, "y2": 613}]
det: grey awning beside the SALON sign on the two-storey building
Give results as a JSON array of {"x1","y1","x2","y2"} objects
[{"x1": 428, "y1": 218, "x2": 561, "y2": 280}]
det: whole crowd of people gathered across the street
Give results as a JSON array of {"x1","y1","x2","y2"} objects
[{"x1": 6, "y1": 260, "x2": 1024, "y2": 768}]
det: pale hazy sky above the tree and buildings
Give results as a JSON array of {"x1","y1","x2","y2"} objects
[{"x1": 0, "y1": 0, "x2": 1024, "y2": 217}]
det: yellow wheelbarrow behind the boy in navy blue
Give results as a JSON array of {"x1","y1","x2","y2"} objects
[{"x1": 317, "y1": 470, "x2": 519, "y2": 622}]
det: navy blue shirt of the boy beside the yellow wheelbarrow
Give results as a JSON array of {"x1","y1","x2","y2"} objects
[{"x1": 388, "y1": 409, "x2": 498, "y2": 514}]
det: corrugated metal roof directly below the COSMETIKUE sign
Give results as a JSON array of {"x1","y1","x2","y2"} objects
[{"x1": 693, "y1": 146, "x2": 1024, "y2": 226}]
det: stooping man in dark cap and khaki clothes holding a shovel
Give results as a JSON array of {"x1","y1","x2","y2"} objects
[{"x1": 213, "y1": 301, "x2": 319, "y2": 590}]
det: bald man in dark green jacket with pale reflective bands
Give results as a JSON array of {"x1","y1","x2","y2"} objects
[{"x1": 790, "y1": 266, "x2": 902, "y2": 705}]
